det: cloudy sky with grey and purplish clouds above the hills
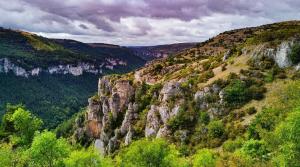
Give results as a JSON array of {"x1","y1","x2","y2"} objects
[{"x1": 0, "y1": 0, "x2": 300, "y2": 46}]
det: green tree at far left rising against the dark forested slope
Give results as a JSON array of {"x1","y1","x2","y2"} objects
[{"x1": 10, "y1": 108, "x2": 43, "y2": 144}]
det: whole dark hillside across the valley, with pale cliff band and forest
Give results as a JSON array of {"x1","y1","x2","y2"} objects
[{"x1": 0, "y1": 28, "x2": 145, "y2": 128}]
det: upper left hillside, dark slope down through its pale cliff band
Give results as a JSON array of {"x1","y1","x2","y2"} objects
[{"x1": 0, "y1": 28, "x2": 145, "y2": 77}]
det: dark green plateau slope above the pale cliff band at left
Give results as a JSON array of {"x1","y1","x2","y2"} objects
[{"x1": 0, "y1": 28, "x2": 145, "y2": 69}]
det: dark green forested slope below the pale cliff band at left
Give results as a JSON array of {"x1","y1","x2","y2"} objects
[{"x1": 0, "y1": 73, "x2": 98, "y2": 128}]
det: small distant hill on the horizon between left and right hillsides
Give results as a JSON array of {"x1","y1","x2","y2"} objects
[{"x1": 129, "y1": 43, "x2": 196, "y2": 61}]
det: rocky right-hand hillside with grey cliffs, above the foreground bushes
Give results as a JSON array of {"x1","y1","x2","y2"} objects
[{"x1": 75, "y1": 21, "x2": 299, "y2": 154}]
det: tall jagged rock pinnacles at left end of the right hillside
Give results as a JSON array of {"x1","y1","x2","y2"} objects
[{"x1": 77, "y1": 77, "x2": 138, "y2": 154}]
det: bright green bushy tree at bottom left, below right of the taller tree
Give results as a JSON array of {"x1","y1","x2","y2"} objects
[{"x1": 28, "y1": 131, "x2": 70, "y2": 167}]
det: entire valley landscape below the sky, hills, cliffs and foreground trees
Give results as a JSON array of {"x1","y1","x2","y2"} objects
[{"x1": 0, "y1": 21, "x2": 300, "y2": 167}]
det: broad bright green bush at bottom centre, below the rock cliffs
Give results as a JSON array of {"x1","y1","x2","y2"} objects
[{"x1": 117, "y1": 139, "x2": 188, "y2": 167}]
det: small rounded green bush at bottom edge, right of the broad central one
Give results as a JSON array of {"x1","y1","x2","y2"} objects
[{"x1": 193, "y1": 149, "x2": 217, "y2": 167}]
